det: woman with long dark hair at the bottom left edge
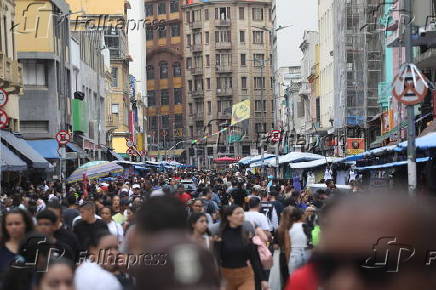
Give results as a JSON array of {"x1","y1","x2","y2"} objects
[{"x1": 0, "y1": 208, "x2": 33, "y2": 280}]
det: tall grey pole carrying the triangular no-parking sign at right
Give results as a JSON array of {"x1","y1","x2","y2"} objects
[{"x1": 403, "y1": 0, "x2": 416, "y2": 196}]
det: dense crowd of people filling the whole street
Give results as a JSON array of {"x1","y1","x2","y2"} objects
[{"x1": 0, "y1": 170, "x2": 436, "y2": 290}]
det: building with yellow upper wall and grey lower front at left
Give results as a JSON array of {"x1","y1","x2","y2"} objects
[{"x1": 15, "y1": 0, "x2": 72, "y2": 139}]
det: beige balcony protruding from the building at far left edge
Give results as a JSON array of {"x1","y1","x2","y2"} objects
[{"x1": 0, "y1": 51, "x2": 23, "y2": 94}]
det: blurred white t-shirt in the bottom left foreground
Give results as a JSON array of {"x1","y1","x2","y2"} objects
[{"x1": 74, "y1": 261, "x2": 123, "y2": 290}]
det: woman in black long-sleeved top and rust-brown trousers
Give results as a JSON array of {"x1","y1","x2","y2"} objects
[{"x1": 214, "y1": 205, "x2": 269, "y2": 290}]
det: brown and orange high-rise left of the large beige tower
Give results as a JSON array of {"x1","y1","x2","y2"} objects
[{"x1": 145, "y1": 0, "x2": 187, "y2": 161}]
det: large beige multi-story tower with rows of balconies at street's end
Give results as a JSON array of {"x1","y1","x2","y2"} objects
[{"x1": 183, "y1": 0, "x2": 275, "y2": 166}]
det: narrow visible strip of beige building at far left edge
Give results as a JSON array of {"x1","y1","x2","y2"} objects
[{"x1": 0, "y1": 0, "x2": 23, "y2": 132}]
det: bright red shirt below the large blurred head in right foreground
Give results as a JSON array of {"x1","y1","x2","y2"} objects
[{"x1": 285, "y1": 264, "x2": 318, "y2": 290}]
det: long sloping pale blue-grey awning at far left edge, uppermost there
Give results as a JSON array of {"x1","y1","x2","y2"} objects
[{"x1": 0, "y1": 130, "x2": 50, "y2": 169}]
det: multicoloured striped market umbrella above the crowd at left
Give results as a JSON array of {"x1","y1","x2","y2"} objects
[{"x1": 67, "y1": 161, "x2": 123, "y2": 183}]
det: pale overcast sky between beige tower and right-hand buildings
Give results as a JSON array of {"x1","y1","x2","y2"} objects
[{"x1": 277, "y1": 0, "x2": 323, "y2": 67}]
